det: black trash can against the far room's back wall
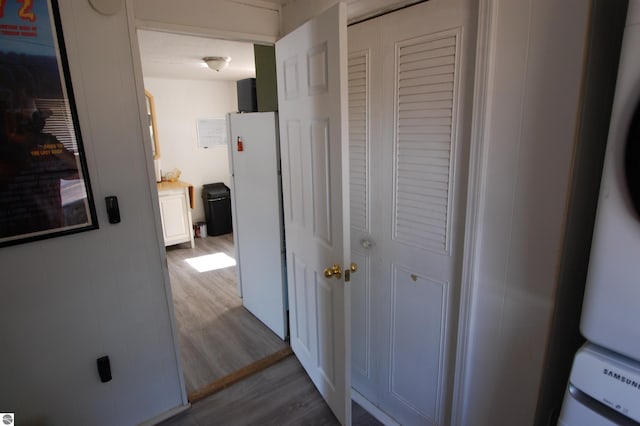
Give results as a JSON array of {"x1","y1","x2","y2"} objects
[{"x1": 202, "y1": 182, "x2": 233, "y2": 236}]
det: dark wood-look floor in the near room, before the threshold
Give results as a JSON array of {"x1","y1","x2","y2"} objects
[{"x1": 161, "y1": 356, "x2": 382, "y2": 426}]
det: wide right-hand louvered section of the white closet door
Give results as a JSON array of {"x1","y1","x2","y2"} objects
[{"x1": 394, "y1": 34, "x2": 457, "y2": 253}]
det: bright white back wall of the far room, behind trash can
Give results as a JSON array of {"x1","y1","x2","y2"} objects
[{"x1": 144, "y1": 78, "x2": 238, "y2": 223}]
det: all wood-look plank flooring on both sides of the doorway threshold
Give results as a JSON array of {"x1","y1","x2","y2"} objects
[{"x1": 162, "y1": 234, "x2": 381, "y2": 426}]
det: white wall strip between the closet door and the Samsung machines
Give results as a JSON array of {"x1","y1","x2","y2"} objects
[{"x1": 458, "y1": 0, "x2": 589, "y2": 426}]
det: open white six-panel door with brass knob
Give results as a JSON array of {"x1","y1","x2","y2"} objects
[{"x1": 276, "y1": 3, "x2": 351, "y2": 424}]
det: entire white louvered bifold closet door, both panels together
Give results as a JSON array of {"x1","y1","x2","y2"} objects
[{"x1": 349, "y1": 0, "x2": 473, "y2": 426}]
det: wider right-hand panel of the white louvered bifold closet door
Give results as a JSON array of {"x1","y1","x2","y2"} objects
[{"x1": 372, "y1": 21, "x2": 462, "y2": 425}]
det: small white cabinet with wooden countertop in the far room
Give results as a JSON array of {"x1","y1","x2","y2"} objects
[{"x1": 158, "y1": 182, "x2": 194, "y2": 248}]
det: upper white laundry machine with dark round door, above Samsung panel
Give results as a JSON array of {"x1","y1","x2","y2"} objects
[{"x1": 580, "y1": 0, "x2": 640, "y2": 360}]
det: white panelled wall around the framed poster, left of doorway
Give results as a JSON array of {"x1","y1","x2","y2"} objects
[{"x1": 0, "y1": 0, "x2": 186, "y2": 425}]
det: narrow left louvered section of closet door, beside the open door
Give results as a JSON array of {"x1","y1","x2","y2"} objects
[{"x1": 348, "y1": 52, "x2": 369, "y2": 232}]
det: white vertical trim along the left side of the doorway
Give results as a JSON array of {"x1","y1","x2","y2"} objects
[{"x1": 125, "y1": 0, "x2": 189, "y2": 410}]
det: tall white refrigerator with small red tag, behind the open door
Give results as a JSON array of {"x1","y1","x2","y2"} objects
[{"x1": 227, "y1": 112, "x2": 288, "y2": 339}]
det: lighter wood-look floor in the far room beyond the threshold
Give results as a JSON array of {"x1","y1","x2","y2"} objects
[{"x1": 167, "y1": 234, "x2": 288, "y2": 393}]
